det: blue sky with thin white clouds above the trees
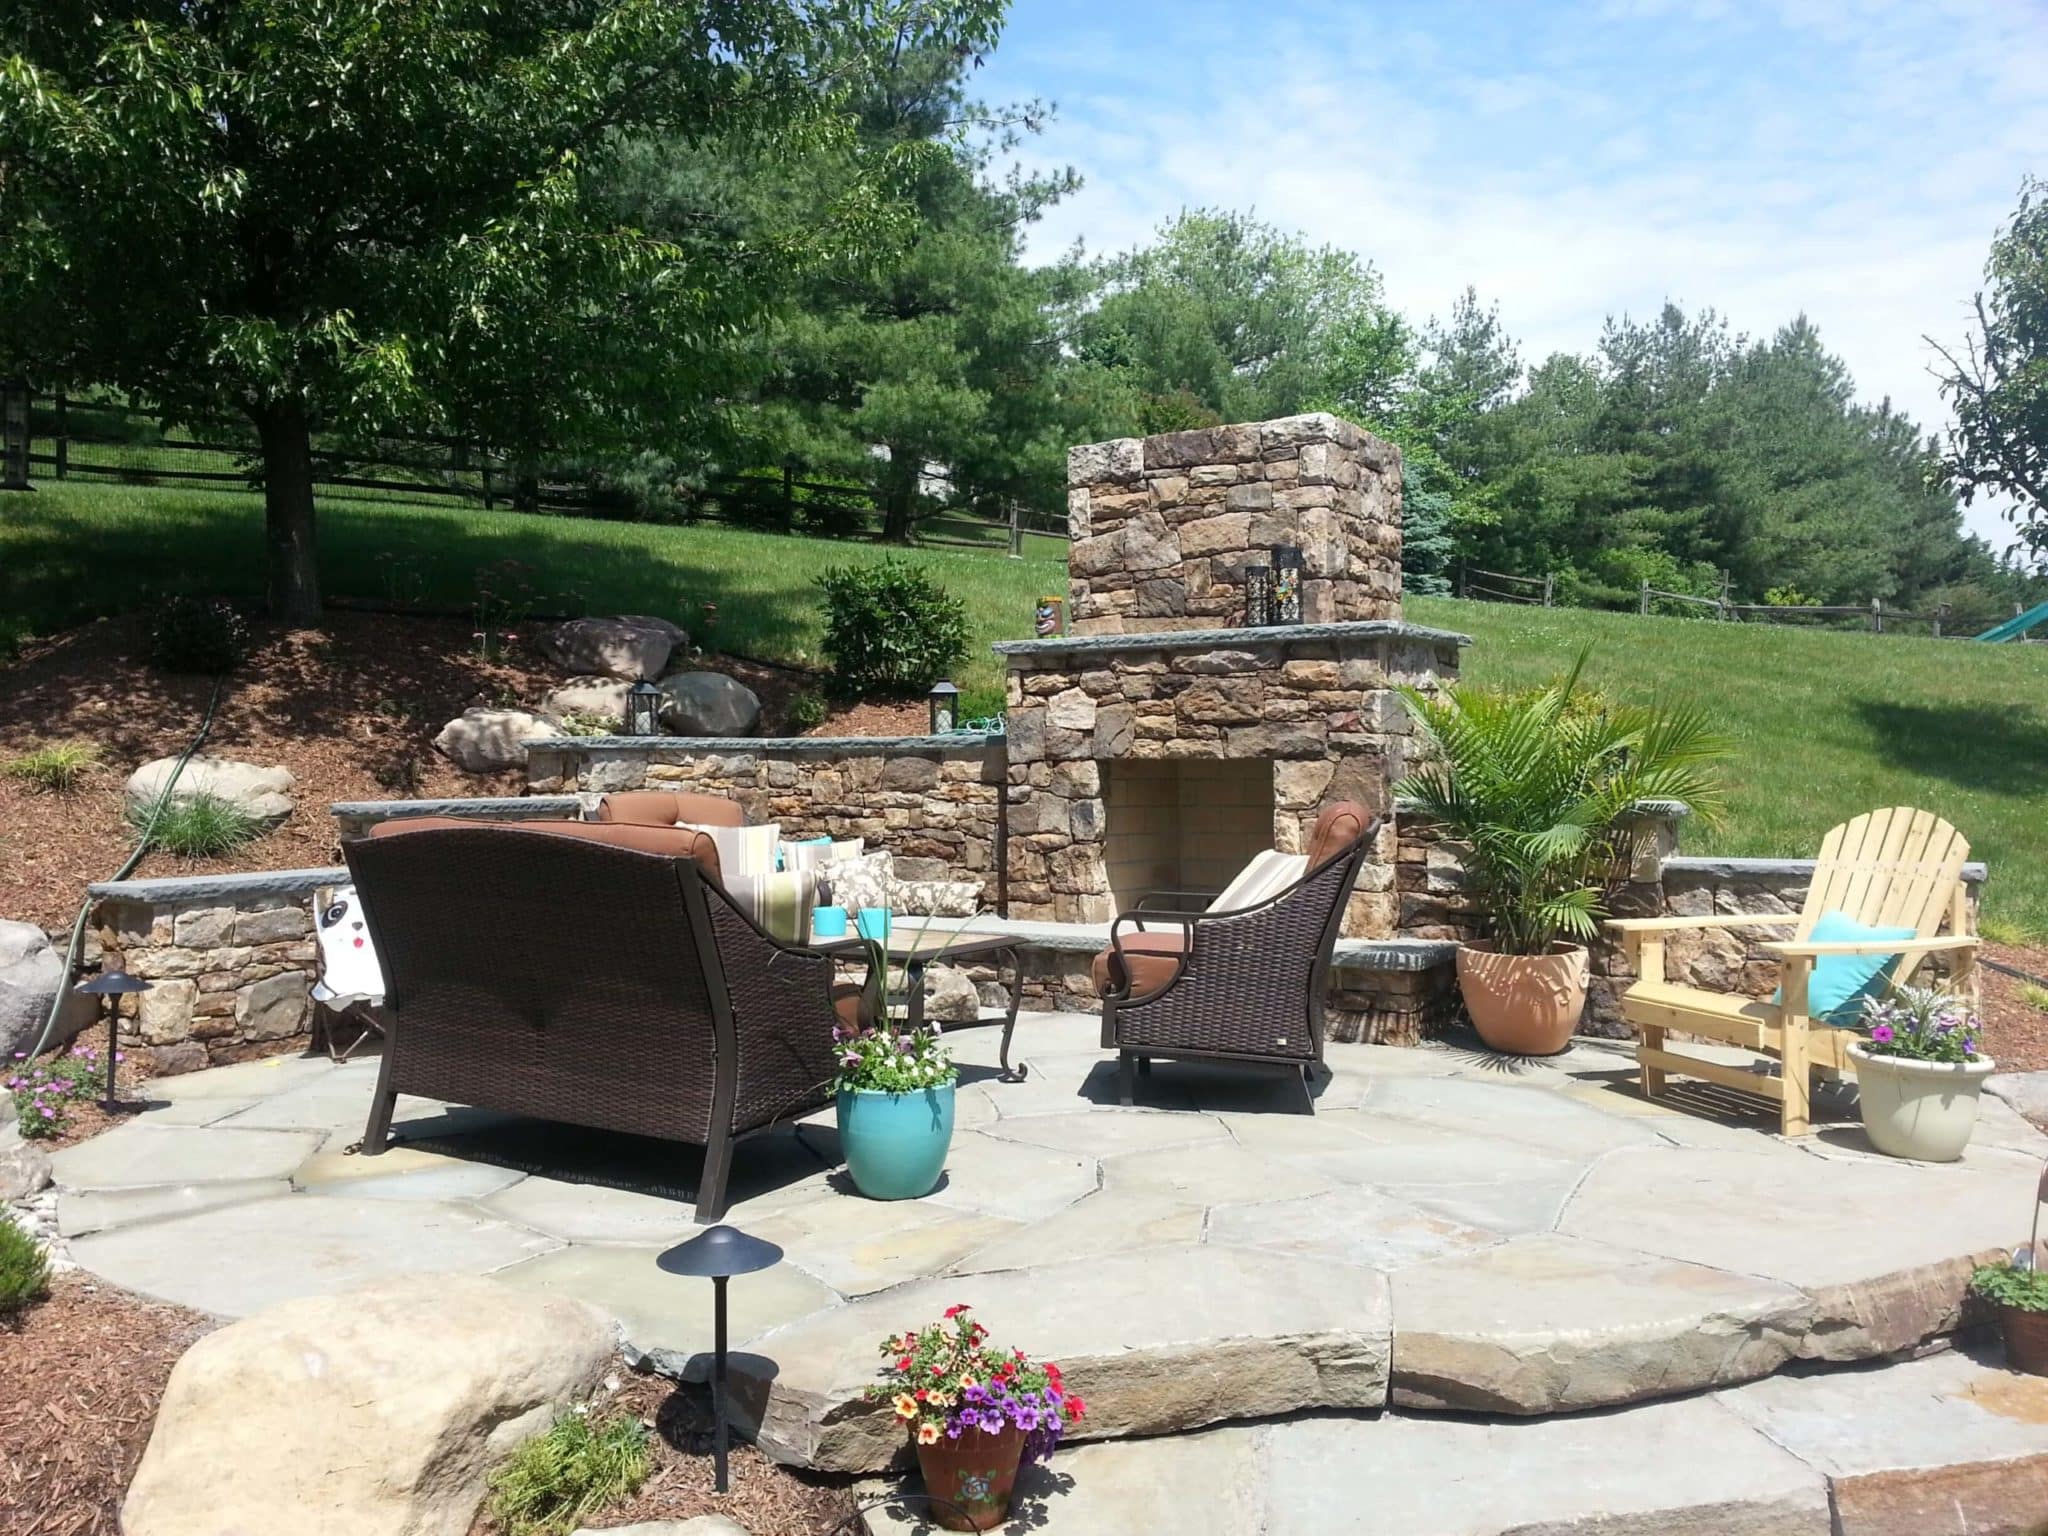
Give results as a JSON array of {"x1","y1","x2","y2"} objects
[{"x1": 977, "y1": 0, "x2": 2048, "y2": 547}]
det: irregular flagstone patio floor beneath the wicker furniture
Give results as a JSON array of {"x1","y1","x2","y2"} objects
[{"x1": 55, "y1": 1014, "x2": 2048, "y2": 1470}]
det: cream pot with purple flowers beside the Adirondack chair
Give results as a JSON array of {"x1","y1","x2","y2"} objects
[{"x1": 1849, "y1": 987, "x2": 1997, "y2": 1163}]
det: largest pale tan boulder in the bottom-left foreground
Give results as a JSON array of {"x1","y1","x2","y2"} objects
[{"x1": 121, "y1": 1274, "x2": 614, "y2": 1536}]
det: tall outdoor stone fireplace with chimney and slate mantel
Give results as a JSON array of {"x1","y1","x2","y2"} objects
[{"x1": 995, "y1": 416, "x2": 1464, "y2": 938}]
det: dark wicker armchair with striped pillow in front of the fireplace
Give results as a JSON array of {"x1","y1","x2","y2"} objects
[{"x1": 1096, "y1": 801, "x2": 1380, "y2": 1114}]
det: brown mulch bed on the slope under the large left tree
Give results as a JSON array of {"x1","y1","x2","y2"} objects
[{"x1": 0, "y1": 612, "x2": 888, "y2": 930}]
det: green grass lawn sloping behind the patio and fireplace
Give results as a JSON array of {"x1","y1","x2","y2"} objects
[{"x1": 12, "y1": 481, "x2": 2048, "y2": 938}]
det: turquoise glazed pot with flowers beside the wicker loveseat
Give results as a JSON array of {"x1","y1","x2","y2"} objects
[{"x1": 834, "y1": 1020, "x2": 958, "y2": 1200}]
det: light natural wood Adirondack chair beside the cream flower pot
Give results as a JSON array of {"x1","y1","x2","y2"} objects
[{"x1": 1608, "y1": 805, "x2": 1976, "y2": 1137}]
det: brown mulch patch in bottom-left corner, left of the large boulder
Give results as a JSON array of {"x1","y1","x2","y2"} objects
[{"x1": 0, "y1": 1274, "x2": 217, "y2": 1536}]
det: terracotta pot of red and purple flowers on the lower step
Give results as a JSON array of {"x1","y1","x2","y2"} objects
[{"x1": 866, "y1": 1303, "x2": 1085, "y2": 1530}]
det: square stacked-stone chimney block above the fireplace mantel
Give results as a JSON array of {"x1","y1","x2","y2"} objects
[{"x1": 1067, "y1": 414, "x2": 1401, "y2": 635}]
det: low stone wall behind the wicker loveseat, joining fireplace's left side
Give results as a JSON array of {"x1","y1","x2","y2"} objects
[{"x1": 526, "y1": 731, "x2": 1004, "y2": 905}]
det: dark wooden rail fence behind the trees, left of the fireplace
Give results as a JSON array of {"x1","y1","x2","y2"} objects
[{"x1": 23, "y1": 395, "x2": 1067, "y2": 557}]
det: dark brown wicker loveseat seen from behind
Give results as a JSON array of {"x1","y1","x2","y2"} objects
[{"x1": 346, "y1": 823, "x2": 848, "y2": 1221}]
